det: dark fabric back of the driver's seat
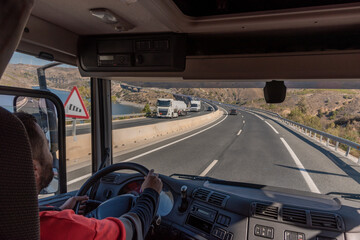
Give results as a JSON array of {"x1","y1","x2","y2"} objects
[{"x1": 0, "y1": 107, "x2": 40, "y2": 240}]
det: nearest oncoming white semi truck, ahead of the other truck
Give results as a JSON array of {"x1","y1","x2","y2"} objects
[{"x1": 156, "y1": 98, "x2": 187, "y2": 118}]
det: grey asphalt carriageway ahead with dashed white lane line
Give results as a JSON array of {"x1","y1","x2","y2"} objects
[{"x1": 67, "y1": 107, "x2": 360, "y2": 197}]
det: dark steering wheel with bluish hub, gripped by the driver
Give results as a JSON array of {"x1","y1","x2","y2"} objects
[{"x1": 75, "y1": 162, "x2": 149, "y2": 219}]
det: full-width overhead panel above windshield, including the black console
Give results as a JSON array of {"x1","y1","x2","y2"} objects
[{"x1": 77, "y1": 33, "x2": 360, "y2": 79}]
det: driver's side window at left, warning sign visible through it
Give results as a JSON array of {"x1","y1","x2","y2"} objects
[{"x1": 0, "y1": 52, "x2": 91, "y2": 192}]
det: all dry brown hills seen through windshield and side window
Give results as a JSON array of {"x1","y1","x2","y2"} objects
[{"x1": 0, "y1": 64, "x2": 360, "y2": 154}]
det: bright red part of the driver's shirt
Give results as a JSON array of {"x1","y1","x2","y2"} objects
[{"x1": 39, "y1": 210, "x2": 126, "y2": 240}]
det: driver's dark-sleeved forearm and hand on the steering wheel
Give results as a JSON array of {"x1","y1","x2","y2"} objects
[{"x1": 120, "y1": 170, "x2": 162, "y2": 240}]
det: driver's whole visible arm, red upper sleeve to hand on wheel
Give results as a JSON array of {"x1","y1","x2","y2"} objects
[{"x1": 39, "y1": 170, "x2": 162, "y2": 240}]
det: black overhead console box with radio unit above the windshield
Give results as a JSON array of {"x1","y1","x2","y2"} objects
[{"x1": 78, "y1": 33, "x2": 186, "y2": 76}]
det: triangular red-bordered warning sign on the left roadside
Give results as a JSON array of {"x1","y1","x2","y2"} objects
[{"x1": 64, "y1": 86, "x2": 89, "y2": 119}]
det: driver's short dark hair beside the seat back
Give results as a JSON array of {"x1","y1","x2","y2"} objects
[{"x1": 14, "y1": 112, "x2": 44, "y2": 166}]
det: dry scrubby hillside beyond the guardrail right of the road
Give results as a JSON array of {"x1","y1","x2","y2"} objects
[{"x1": 173, "y1": 88, "x2": 360, "y2": 156}]
